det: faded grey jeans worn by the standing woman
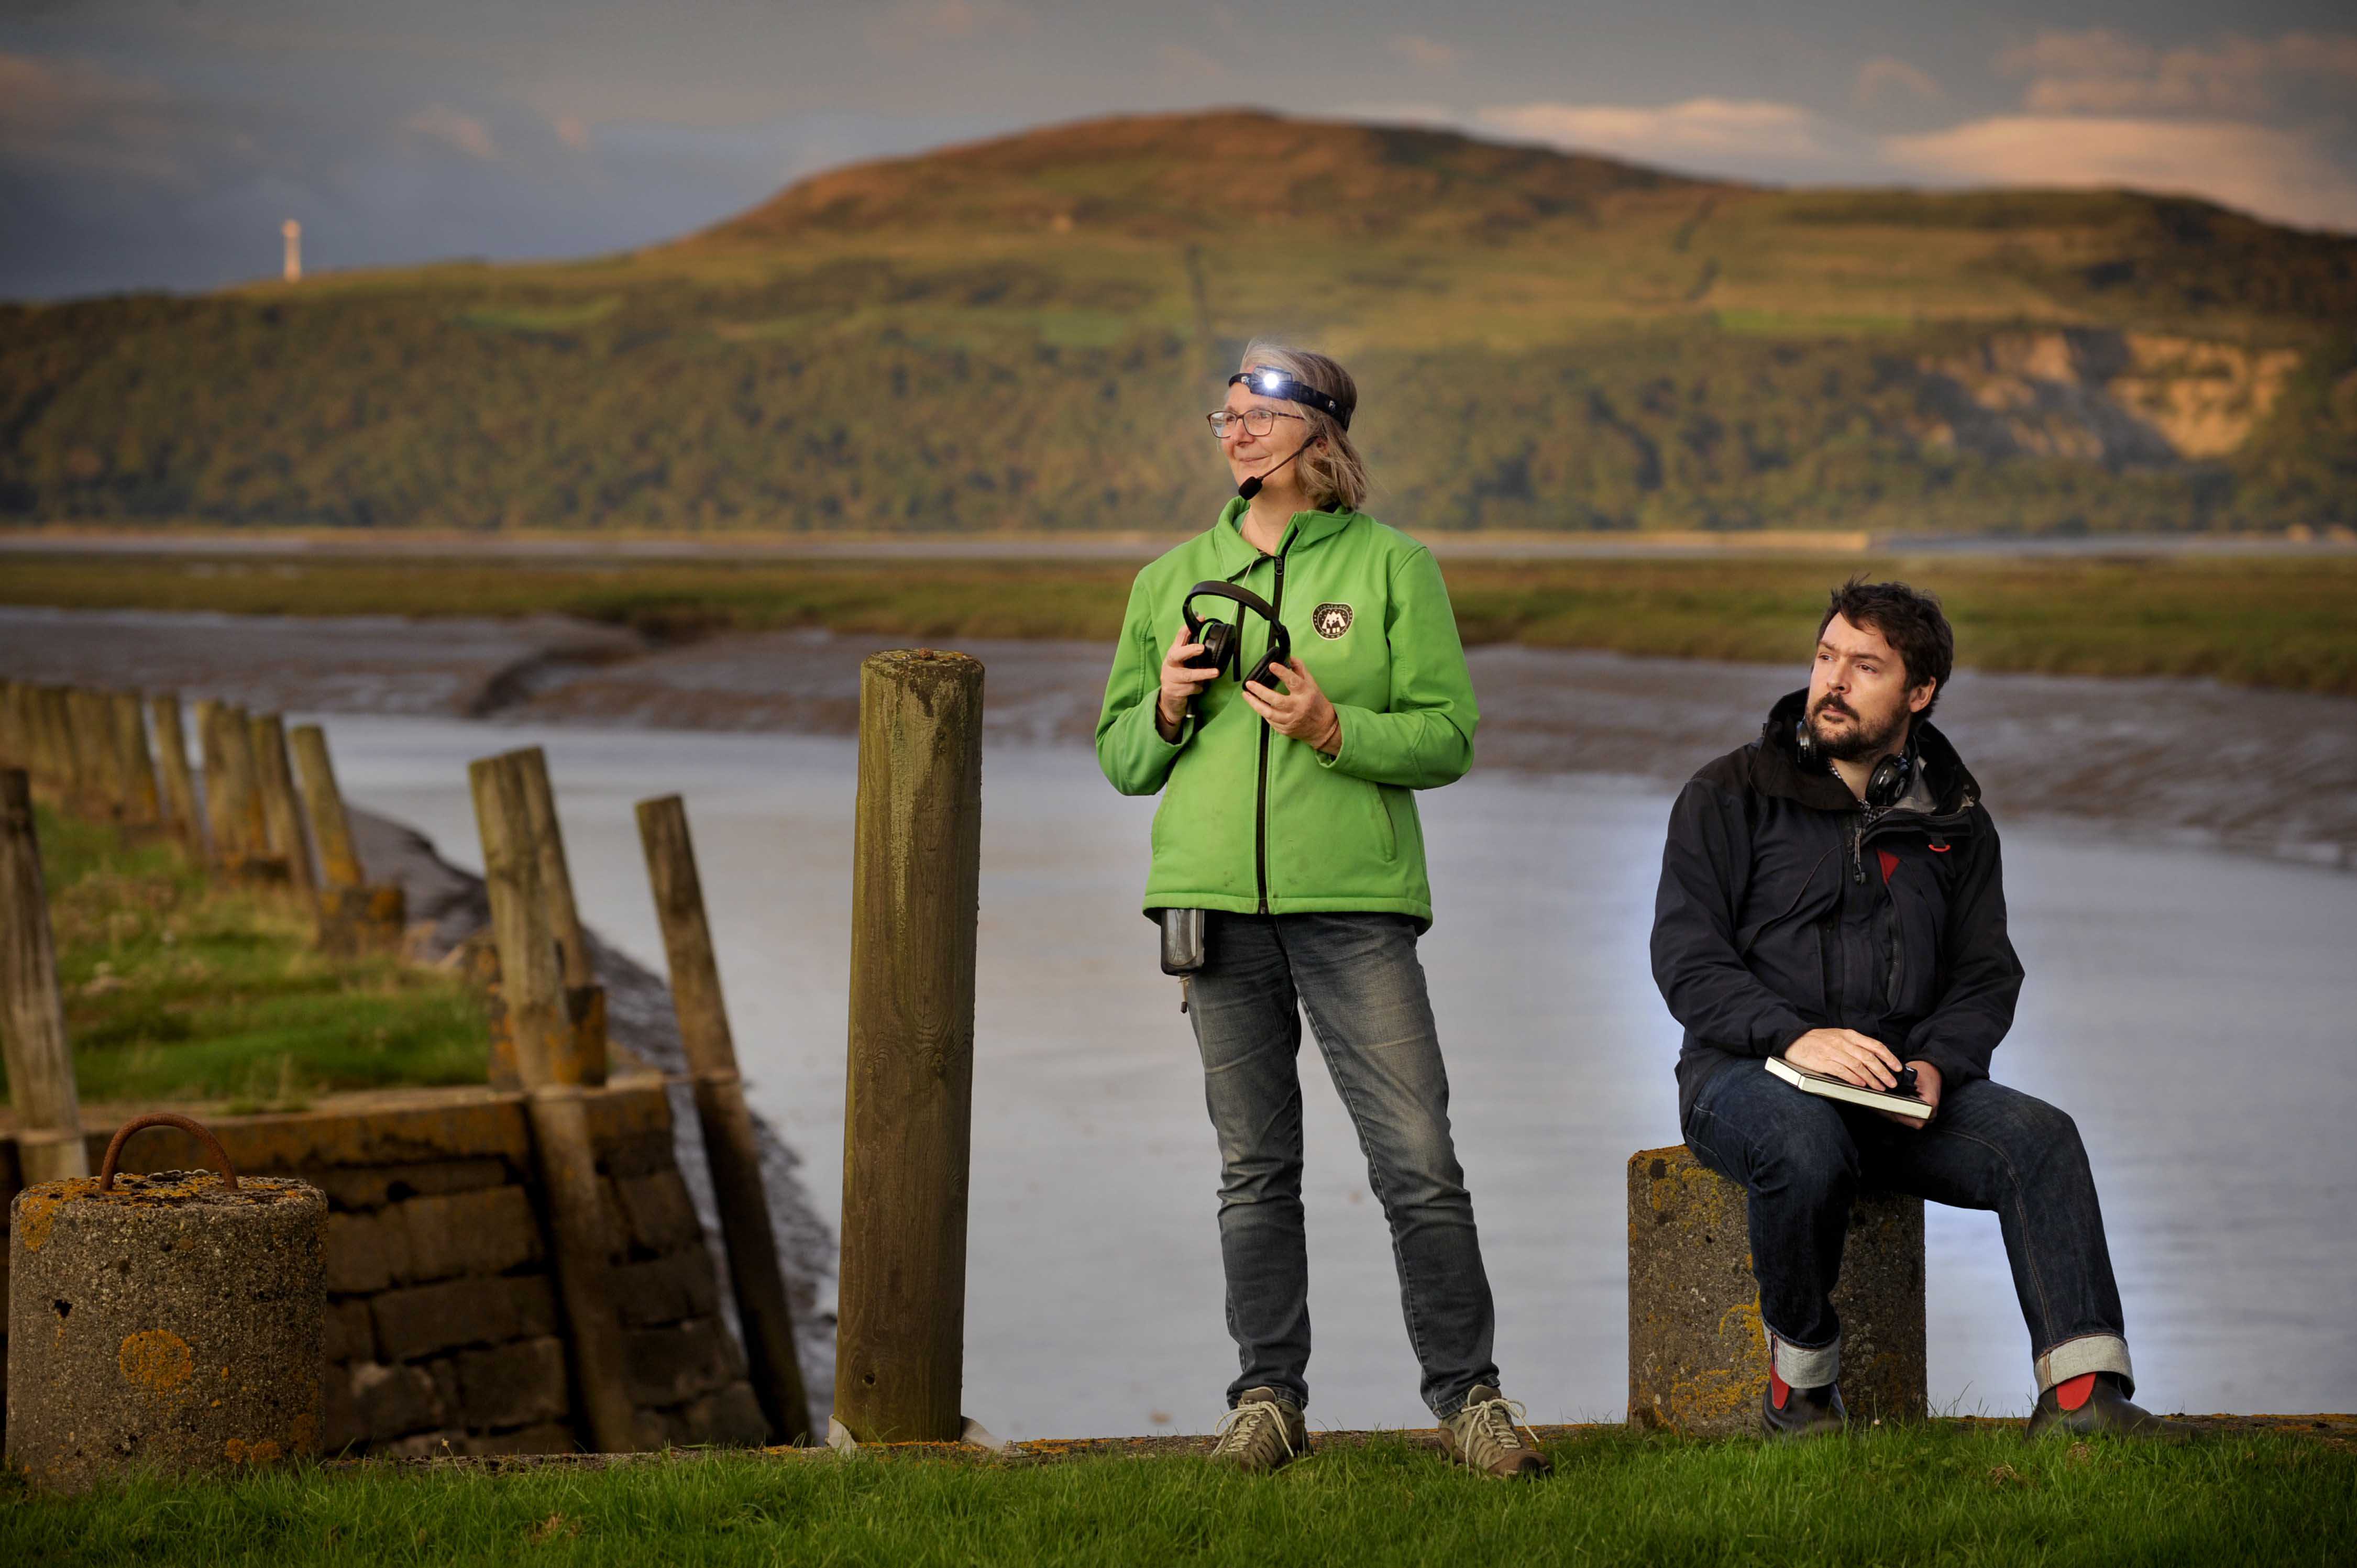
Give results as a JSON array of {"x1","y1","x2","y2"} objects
[{"x1": 1191, "y1": 910, "x2": 1497, "y2": 1415}]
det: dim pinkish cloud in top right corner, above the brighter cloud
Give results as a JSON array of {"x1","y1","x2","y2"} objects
[{"x1": 1997, "y1": 28, "x2": 2357, "y2": 118}]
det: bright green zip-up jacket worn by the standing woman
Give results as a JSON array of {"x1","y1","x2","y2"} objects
[{"x1": 1096, "y1": 500, "x2": 1480, "y2": 924}]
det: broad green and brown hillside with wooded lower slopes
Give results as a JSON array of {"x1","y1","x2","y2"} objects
[{"x1": 0, "y1": 113, "x2": 2357, "y2": 531}]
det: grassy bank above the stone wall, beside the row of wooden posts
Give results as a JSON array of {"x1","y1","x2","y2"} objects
[{"x1": 0, "y1": 811, "x2": 486, "y2": 1113}]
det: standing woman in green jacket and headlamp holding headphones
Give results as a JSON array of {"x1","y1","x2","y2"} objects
[{"x1": 1096, "y1": 344, "x2": 1546, "y2": 1476}]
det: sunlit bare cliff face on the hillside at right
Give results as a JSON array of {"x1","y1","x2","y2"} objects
[{"x1": 1921, "y1": 328, "x2": 2300, "y2": 469}]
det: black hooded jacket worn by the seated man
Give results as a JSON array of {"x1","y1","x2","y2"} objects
[{"x1": 1653, "y1": 691, "x2": 2022, "y2": 1122}]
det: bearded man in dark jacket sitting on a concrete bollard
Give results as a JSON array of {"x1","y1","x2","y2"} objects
[{"x1": 1653, "y1": 580, "x2": 2187, "y2": 1436}]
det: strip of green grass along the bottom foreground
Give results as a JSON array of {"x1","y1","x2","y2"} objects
[{"x1": 0, "y1": 1429, "x2": 2357, "y2": 1568}]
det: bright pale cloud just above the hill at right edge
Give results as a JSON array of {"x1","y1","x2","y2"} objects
[{"x1": 1881, "y1": 113, "x2": 2357, "y2": 229}]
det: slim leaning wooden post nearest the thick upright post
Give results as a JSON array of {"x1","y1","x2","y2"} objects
[{"x1": 467, "y1": 755, "x2": 646, "y2": 1452}]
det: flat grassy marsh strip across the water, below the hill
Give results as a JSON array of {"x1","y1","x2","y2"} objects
[{"x1": 0, "y1": 554, "x2": 2357, "y2": 695}]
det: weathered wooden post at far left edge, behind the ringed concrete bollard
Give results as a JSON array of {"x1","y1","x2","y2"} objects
[{"x1": 0, "y1": 769, "x2": 90, "y2": 1186}]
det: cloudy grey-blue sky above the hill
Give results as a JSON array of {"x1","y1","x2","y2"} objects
[{"x1": 0, "y1": 0, "x2": 2357, "y2": 300}]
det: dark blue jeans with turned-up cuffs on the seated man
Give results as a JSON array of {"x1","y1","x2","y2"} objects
[{"x1": 1686, "y1": 1061, "x2": 2135, "y2": 1391}]
